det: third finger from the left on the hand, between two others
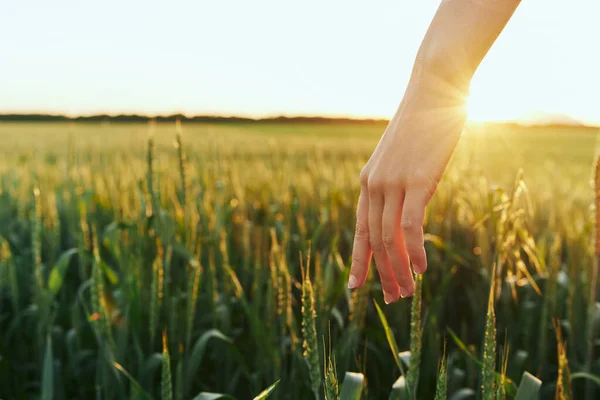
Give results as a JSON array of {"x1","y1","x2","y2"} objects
[{"x1": 381, "y1": 189, "x2": 415, "y2": 297}]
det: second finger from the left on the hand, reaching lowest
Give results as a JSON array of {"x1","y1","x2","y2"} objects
[{"x1": 369, "y1": 187, "x2": 400, "y2": 304}]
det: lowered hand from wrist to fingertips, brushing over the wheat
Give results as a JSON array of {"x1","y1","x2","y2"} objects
[{"x1": 348, "y1": 82, "x2": 466, "y2": 303}]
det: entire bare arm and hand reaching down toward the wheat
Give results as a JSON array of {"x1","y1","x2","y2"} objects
[{"x1": 348, "y1": 0, "x2": 520, "y2": 303}]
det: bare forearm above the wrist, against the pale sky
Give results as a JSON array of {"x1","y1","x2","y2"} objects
[{"x1": 411, "y1": 0, "x2": 520, "y2": 93}]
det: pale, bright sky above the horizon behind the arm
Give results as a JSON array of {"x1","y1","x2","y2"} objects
[{"x1": 0, "y1": 0, "x2": 600, "y2": 124}]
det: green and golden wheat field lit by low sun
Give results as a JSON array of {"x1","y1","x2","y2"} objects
[{"x1": 0, "y1": 123, "x2": 600, "y2": 400}]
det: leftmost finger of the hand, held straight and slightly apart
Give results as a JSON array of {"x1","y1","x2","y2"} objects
[{"x1": 348, "y1": 185, "x2": 371, "y2": 289}]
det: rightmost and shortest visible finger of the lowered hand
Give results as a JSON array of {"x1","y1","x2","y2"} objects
[{"x1": 401, "y1": 189, "x2": 428, "y2": 274}]
